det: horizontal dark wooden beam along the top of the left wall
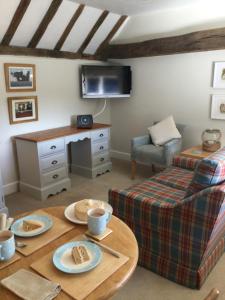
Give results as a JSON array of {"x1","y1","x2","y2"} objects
[{"x1": 0, "y1": 45, "x2": 102, "y2": 60}]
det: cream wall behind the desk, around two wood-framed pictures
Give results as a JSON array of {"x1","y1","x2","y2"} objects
[{"x1": 0, "y1": 56, "x2": 110, "y2": 193}]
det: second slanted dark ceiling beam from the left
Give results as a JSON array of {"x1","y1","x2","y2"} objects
[{"x1": 28, "y1": 0, "x2": 63, "y2": 48}]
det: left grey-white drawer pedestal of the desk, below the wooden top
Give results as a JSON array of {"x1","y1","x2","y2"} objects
[{"x1": 16, "y1": 138, "x2": 71, "y2": 200}]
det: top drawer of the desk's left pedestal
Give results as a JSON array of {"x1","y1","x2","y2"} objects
[{"x1": 38, "y1": 138, "x2": 65, "y2": 156}]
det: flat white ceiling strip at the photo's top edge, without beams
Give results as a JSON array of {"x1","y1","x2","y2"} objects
[{"x1": 70, "y1": 0, "x2": 203, "y2": 16}]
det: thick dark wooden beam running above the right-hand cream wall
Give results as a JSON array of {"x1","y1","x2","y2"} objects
[{"x1": 104, "y1": 28, "x2": 225, "y2": 59}]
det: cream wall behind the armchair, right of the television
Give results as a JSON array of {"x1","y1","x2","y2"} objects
[{"x1": 111, "y1": 50, "x2": 225, "y2": 158}]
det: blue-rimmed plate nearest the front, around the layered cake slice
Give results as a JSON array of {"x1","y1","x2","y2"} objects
[{"x1": 53, "y1": 241, "x2": 102, "y2": 274}]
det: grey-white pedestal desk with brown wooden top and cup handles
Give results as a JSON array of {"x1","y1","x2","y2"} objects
[{"x1": 15, "y1": 123, "x2": 112, "y2": 200}]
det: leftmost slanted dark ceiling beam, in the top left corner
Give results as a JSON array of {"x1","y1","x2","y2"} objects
[{"x1": 1, "y1": 0, "x2": 31, "y2": 46}]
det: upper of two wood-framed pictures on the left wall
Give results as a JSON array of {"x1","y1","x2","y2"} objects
[{"x1": 4, "y1": 63, "x2": 36, "y2": 92}]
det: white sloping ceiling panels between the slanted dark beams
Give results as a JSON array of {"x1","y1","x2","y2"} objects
[{"x1": 0, "y1": 0, "x2": 123, "y2": 54}]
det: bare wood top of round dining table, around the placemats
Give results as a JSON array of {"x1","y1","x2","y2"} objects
[{"x1": 0, "y1": 206, "x2": 138, "y2": 300}]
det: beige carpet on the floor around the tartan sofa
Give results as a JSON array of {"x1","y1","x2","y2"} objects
[{"x1": 6, "y1": 160, "x2": 225, "y2": 300}]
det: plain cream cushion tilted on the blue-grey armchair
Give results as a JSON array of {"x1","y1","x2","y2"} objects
[{"x1": 148, "y1": 116, "x2": 181, "y2": 145}]
